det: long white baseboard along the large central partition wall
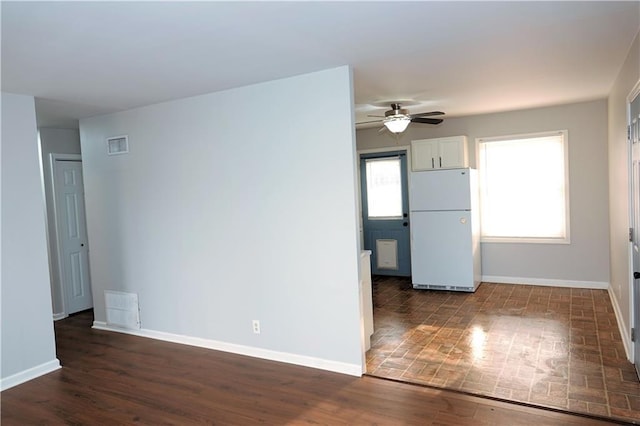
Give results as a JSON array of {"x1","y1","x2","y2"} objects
[{"x1": 93, "y1": 321, "x2": 363, "y2": 377}]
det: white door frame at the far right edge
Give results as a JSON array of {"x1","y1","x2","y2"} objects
[{"x1": 620, "y1": 80, "x2": 640, "y2": 371}]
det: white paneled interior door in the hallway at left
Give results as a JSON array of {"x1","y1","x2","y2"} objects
[{"x1": 54, "y1": 160, "x2": 93, "y2": 314}]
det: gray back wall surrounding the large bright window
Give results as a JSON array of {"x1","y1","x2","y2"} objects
[{"x1": 356, "y1": 99, "x2": 609, "y2": 286}]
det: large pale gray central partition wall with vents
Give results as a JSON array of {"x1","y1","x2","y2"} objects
[{"x1": 80, "y1": 67, "x2": 362, "y2": 368}]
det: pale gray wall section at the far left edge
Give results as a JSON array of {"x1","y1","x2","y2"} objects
[{"x1": 1, "y1": 93, "x2": 59, "y2": 388}]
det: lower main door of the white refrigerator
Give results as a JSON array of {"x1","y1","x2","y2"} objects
[{"x1": 411, "y1": 211, "x2": 474, "y2": 291}]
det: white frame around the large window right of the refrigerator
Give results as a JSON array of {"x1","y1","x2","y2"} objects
[{"x1": 475, "y1": 130, "x2": 571, "y2": 244}]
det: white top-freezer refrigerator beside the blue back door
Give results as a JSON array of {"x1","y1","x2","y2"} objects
[{"x1": 409, "y1": 168, "x2": 482, "y2": 292}]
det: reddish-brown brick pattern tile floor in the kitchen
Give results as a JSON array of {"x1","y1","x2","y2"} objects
[{"x1": 367, "y1": 276, "x2": 640, "y2": 421}]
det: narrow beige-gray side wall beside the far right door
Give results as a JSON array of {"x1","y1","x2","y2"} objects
[{"x1": 608, "y1": 29, "x2": 640, "y2": 347}]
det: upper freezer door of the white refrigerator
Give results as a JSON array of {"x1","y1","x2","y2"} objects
[{"x1": 409, "y1": 169, "x2": 475, "y2": 211}]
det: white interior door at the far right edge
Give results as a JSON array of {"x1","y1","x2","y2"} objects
[{"x1": 629, "y1": 91, "x2": 640, "y2": 377}]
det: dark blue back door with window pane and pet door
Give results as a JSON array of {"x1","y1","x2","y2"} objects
[{"x1": 360, "y1": 151, "x2": 411, "y2": 276}]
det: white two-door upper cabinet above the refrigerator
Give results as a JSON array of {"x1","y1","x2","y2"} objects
[{"x1": 411, "y1": 136, "x2": 469, "y2": 172}]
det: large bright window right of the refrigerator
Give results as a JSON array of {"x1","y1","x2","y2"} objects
[{"x1": 478, "y1": 131, "x2": 569, "y2": 243}]
